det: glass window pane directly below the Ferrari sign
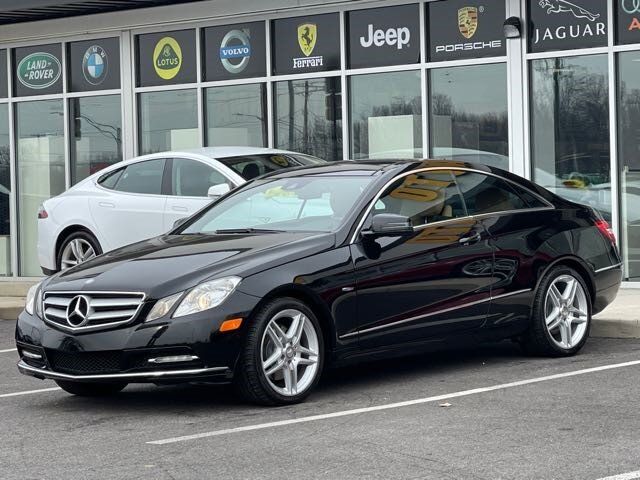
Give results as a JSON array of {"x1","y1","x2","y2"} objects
[{"x1": 274, "y1": 77, "x2": 342, "y2": 160}]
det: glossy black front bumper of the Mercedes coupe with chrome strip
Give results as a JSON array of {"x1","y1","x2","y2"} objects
[{"x1": 16, "y1": 292, "x2": 259, "y2": 384}]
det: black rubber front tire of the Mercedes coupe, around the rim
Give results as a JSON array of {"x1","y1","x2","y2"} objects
[{"x1": 234, "y1": 297, "x2": 325, "y2": 406}]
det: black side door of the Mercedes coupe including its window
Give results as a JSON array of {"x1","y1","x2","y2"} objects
[{"x1": 352, "y1": 170, "x2": 493, "y2": 348}]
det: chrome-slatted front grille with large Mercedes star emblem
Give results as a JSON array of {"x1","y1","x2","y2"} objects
[{"x1": 43, "y1": 292, "x2": 145, "y2": 331}]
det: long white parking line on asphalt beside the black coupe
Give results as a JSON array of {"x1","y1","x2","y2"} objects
[{"x1": 147, "y1": 360, "x2": 640, "y2": 444}]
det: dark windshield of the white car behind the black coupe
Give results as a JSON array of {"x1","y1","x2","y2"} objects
[{"x1": 217, "y1": 153, "x2": 326, "y2": 180}]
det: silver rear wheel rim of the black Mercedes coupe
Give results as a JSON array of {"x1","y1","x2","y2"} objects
[{"x1": 544, "y1": 275, "x2": 589, "y2": 349}]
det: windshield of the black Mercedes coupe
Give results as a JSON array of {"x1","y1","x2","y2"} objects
[{"x1": 179, "y1": 175, "x2": 372, "y2": 235}]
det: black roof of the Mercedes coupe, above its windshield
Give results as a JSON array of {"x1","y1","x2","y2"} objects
[{"x1": 261, "y1": 159, "x2": 502, "y2": 178}]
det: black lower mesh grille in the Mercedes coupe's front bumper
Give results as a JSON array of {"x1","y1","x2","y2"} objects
[{"x1": 47, "y1": 350, "x2": 122, "y2": 375}]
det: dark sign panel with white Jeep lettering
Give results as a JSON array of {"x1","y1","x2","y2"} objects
[{"x1": 347, "y1": 4, "x2": 421, "y2": 68}]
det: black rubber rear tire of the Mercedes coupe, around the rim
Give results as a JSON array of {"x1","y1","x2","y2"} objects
[{"x1": 522, "y1": 265, "x2": 592, "y2": 357}]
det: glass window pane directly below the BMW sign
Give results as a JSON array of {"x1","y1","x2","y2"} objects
[{"x1": 69, "y1": 95, "x2": 122, "y2": 184}]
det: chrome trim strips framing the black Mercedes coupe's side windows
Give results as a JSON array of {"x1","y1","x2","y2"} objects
[{"x1": 349, "y1": 167, "x2": 556, "y2": 245}]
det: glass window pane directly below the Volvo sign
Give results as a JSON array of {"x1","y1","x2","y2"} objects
[{"x1": 206, "y1": 84, "x2": 267, "y2": 147}]
